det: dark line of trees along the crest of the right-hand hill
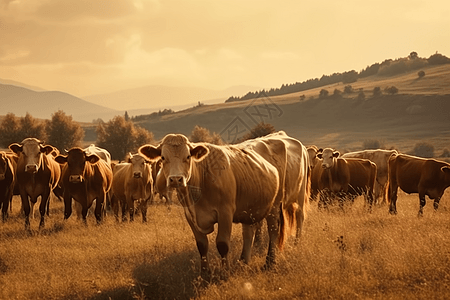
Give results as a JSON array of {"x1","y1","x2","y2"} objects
[{"x1": 229, "y1": 51, "x2": 450, "y2": 102}]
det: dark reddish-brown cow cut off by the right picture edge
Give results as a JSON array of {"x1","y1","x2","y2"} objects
[{"x1": 388, "y1": 154, "x2": 450, "y2": 216}]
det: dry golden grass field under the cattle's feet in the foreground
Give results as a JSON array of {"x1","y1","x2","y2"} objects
[{"x1": 0, "y1": 191, "x2": 450, "y2": 299}]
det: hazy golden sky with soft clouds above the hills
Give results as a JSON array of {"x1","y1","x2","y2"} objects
[{"x1": 0, "y1": 0, "x2": 450, "y2": 96}]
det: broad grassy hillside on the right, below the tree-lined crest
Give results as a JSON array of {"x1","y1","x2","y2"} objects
[{"x1": 135, "y1": 65, "x2": 450, "y2": 154}]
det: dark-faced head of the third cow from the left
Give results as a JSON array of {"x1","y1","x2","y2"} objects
[{"x1": 55, "y1": 147, "x2": 100, "y2": 183}]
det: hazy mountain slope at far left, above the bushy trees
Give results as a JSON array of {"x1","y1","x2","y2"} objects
[{"x1": 0, "y1": 84, "x2": 121, "y2": 122}]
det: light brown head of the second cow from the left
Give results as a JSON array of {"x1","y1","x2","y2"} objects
[{"x1": 9, "y1": 138, "x2": 55, "y2": 173}]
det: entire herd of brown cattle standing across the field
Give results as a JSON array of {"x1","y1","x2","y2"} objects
[{"x1": 0, "y1": 131, "x2": 450, "y2": 275}]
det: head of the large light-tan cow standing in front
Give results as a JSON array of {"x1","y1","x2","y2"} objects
[{"x1": 139, "y1": 134, "x2": 209, "y2": 188}]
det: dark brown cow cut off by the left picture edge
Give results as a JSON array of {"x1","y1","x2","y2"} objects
[{"x1": 0, "y1": 151, "x2": 15, "y2": 222}]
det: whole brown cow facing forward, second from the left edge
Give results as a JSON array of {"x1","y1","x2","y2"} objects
[{"x1": 9, "y1": 138, "x2": 61, "y2": 229}]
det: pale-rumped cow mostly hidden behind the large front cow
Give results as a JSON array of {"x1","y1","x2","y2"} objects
[{"x1": 241, "y1": 131, "x2": 310, "y2": 264}]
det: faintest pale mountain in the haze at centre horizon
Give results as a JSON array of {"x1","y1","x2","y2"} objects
[{"x1": 82, "y1": 85, "x2": 259, "y2": 110}]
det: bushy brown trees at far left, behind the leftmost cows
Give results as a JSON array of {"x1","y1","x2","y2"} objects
[{"x1": 0, "y1": 110, "x2": 84, "y2": 151}]
